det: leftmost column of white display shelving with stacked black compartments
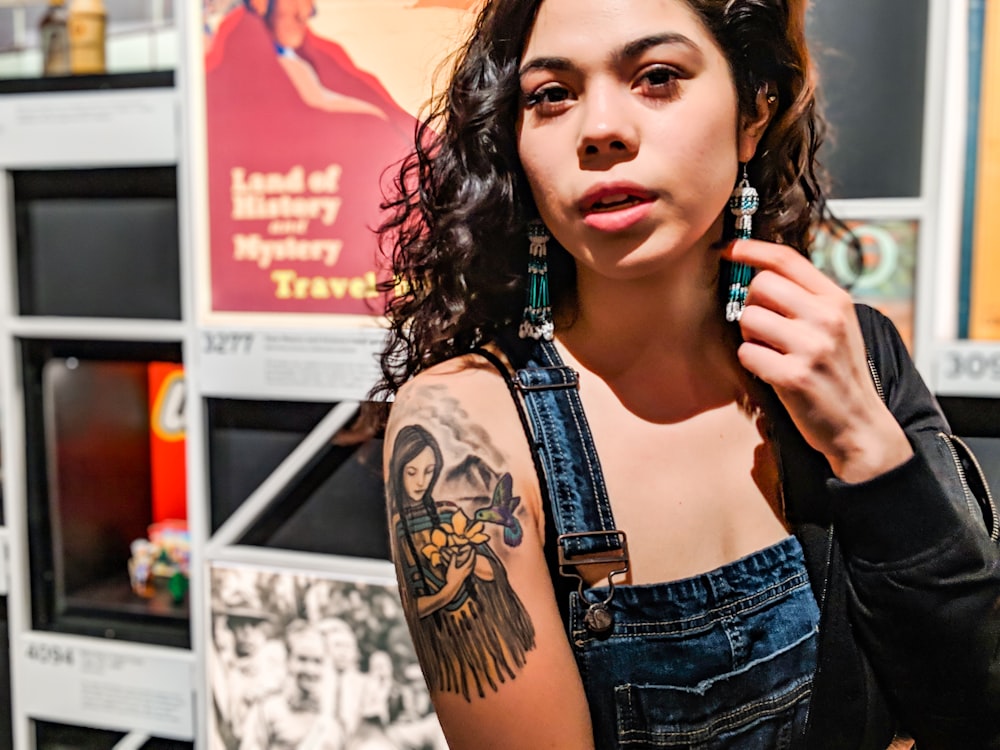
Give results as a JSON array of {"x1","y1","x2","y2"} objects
[{"x1": 0, "y1": 17, "x2": 195, "y2": 750}]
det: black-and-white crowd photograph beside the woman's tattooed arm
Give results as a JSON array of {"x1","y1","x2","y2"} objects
[{"x1": 208, "y1": 563, "x2": 447, "y2": 750}]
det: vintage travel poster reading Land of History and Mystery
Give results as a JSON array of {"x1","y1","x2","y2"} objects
[{"x1": 203, "y1": 0, "x2": 478, "y2": 315}]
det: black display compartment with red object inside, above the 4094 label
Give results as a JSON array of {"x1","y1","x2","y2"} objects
[{"x1": 21, "y1": 340, "x2": 190, "y2": 646}]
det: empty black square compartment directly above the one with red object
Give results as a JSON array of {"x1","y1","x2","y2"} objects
[{"x1": 12, "y1": 167, "x2": 181, "y2": 320}]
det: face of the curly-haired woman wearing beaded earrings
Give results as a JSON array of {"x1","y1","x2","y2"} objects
[{"x1": 518, "y1": 0, "x2": 756, "y2": 279}]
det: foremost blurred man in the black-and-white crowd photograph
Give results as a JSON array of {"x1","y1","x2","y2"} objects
[{"x1": 240, "y1": 620, "x2": 345, "y2": 750}]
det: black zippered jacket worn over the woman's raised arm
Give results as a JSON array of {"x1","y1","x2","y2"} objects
[{"x1": 780, "y1": 305, "x2": 1000, "y2": 750}]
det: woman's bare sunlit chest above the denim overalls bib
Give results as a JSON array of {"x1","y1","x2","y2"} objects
[{"x1": 589, "y1": 396, "x2": 788, "y2": 583}]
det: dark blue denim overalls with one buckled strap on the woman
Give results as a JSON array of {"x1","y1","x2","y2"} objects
[{"x1": 490, "y1": 342, "x2": 819, "y2": 750}]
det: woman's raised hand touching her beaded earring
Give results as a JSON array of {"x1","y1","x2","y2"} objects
[{"x1": 723, "y1": 240, "x2": 912, "y2": 482}]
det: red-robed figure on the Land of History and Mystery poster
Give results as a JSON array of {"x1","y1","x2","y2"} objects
[{"x1": 205, "y1": 0, "x2": 416, "y2": 315}]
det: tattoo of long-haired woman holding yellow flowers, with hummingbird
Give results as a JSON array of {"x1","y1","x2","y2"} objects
[{"x1": 388, "y1": 425, "x2": 534, "y2": 698}]
